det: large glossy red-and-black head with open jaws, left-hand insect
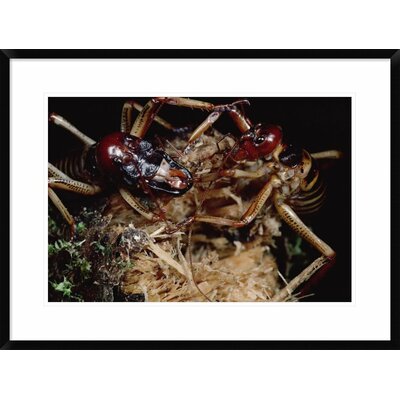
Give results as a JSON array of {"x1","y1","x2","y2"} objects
[{"x1": 95, "y1": 132, "x2": 193, "y2": 196}]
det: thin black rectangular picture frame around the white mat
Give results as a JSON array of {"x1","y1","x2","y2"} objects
[{"x1": 0, "y1": 50, "x2": 400, "y2": 350}]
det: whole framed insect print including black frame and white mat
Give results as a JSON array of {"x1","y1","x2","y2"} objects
[{"x1": 0, "y1": 50, "x2": 400, "y2": 349}]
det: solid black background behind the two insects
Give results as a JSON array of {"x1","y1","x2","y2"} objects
[{"x1": 49, "y1": 97, "x2": 351, "y2": 301}]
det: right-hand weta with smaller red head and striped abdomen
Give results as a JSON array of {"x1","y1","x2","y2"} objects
[{"x1": 180, "y1": 98, "x2": 341, "y2": 261}]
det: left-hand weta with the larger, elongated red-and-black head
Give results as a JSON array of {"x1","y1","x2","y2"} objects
[{"x1": 48, "y1": 98, "x2": 244, "y2": 237}]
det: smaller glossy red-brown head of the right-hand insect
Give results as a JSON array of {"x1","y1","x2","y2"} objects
[{"x1": 232, "y1": 124, "x2": 282, "y2": 161}]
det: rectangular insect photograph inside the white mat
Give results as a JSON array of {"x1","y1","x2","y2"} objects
[{"x1": 47, "y1": 96, "x2": 352, "y2": 303}]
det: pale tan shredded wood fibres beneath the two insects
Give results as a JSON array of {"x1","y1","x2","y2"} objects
[{"x1": 93, "y1": 131, "x2": 284, "y2": 301}]
